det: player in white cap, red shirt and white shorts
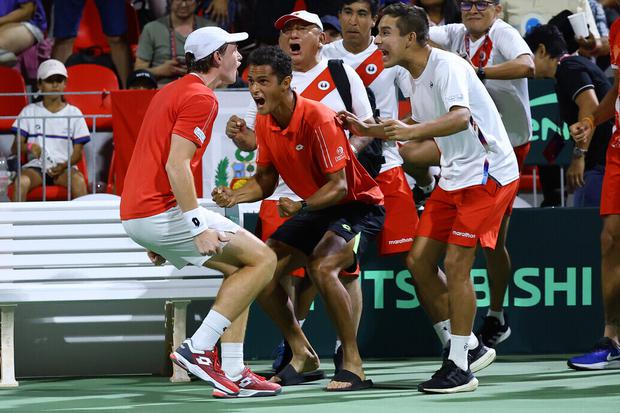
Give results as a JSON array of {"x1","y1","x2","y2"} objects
[{"x1": 120, "y1": 27, "x2": 281, "y2": 397}]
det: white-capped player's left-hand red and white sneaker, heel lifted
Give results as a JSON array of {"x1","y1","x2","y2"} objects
[{"x1": 170, "y1": 339, "x2": 239, "y2": 396}]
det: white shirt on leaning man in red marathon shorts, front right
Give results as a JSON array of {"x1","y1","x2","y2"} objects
[{"x1": 411, "y1": 49, "x2": 519, "y2": 191}]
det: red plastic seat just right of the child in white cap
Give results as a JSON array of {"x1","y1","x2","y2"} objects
[{"x1": 65, "y1": 64, "x2": 118, "y2": 131}]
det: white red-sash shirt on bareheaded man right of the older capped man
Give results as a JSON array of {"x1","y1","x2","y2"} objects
[{"x1": 321, "y1": 38, "x2": 411, "y2": 172}]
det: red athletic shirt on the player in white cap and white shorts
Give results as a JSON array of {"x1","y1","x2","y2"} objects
[{"x1": 121, "y1": 74, "x2": 218, "y2": 220}]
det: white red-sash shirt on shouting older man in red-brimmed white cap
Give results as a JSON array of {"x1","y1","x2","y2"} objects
[{"x1": 244, "y1": 59, "x2": 373, "y2": 200}]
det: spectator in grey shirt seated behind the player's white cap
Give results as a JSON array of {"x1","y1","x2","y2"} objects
[{"x1": 134, "y1": 0, "x2": 215, "y2": 85}]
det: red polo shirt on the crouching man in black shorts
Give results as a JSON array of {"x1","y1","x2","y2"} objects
[{"x1": 255, "y1": 94, "x2": 383, "y2": 205}]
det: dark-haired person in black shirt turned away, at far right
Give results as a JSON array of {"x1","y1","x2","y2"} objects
[{"x1": 525, "y1": 25, "x2": 613, "y2": 208}]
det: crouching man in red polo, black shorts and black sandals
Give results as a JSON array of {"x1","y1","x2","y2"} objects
[{"x1": 213, "y1": 47, "x2": 385, "y2": 391}]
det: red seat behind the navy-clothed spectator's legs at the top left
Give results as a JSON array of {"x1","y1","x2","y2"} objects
[{"x1": 73, "y1": 0, "x2": 140, "y2": 54}]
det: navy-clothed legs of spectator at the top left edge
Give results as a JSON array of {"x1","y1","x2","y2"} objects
[{"x1": 52, "y1": 0, "x2": 131, "y2": 86}]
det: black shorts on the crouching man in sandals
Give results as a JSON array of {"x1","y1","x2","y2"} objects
[{"x1": 270, "y1": 202, "x2": 385, "y2": 256}]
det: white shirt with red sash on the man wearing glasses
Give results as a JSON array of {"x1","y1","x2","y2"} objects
[{"x1": 429, "y1": 19, "x2": 532, "y2": 147}]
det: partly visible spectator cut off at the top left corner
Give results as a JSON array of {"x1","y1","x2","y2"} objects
[{"x1": 0, "y1": 0, "x2": 47, "y2": 66}]
